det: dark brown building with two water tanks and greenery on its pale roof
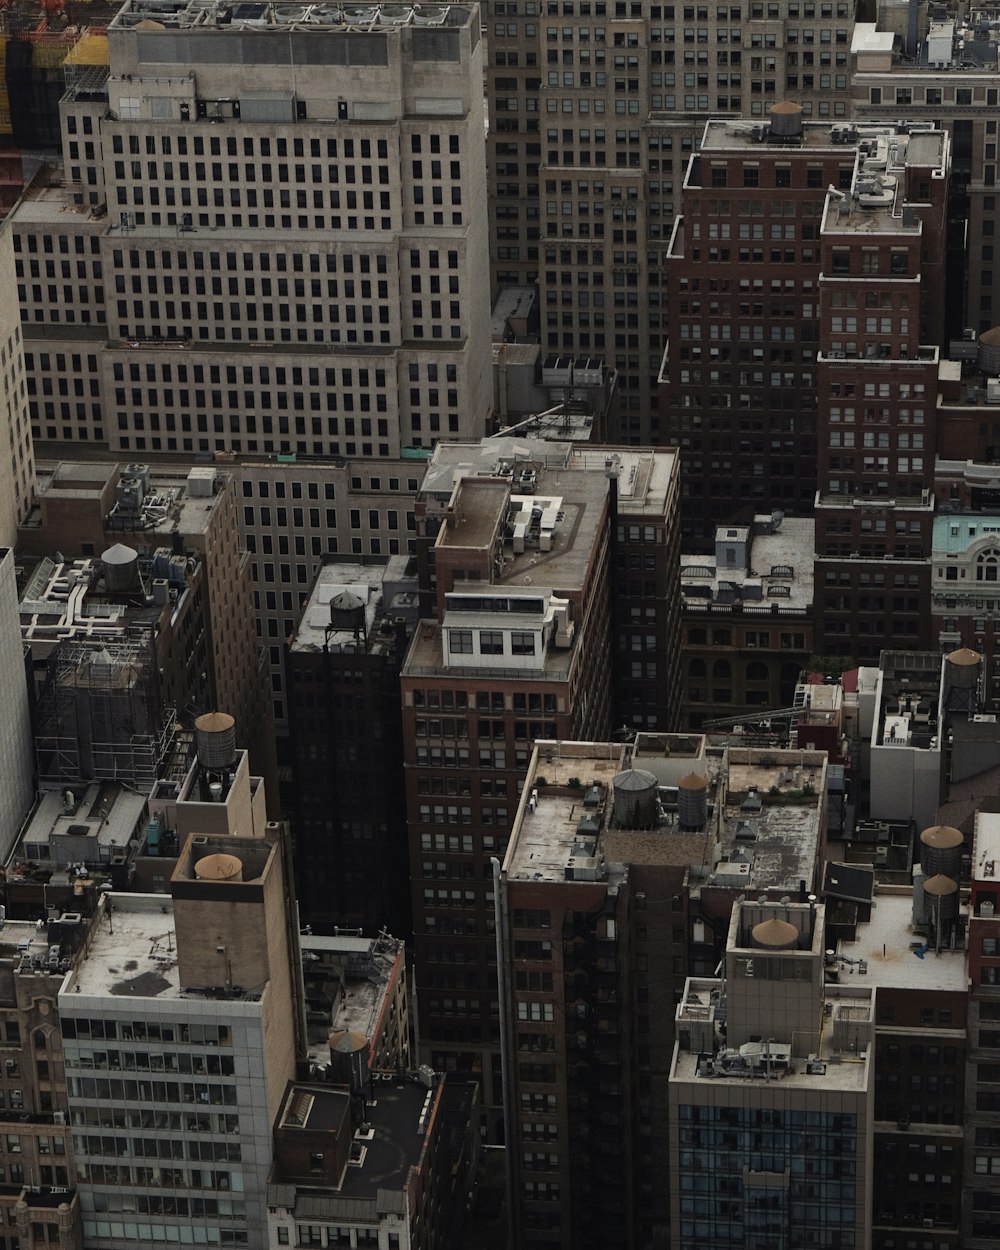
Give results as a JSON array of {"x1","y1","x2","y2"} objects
[{"x1": 499, "y1": 734, "x2": 826, "y2": 1248}]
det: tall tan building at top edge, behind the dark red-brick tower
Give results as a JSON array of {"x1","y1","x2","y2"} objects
[{"x1": 488, "y1": 0, "x2": 855, "y2": 444}]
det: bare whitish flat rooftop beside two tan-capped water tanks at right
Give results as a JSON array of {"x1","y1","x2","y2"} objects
[{"x1": 838, "y1": 886, "x2": 969, "y2": 993}]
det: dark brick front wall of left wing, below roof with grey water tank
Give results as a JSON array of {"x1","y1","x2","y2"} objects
[{"x1": 504, "y1": 879, "x2": 639, "y2": 1250}]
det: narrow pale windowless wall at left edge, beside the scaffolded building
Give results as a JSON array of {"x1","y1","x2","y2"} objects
[{"x1": 0, "y1": 548, "x2": 35, "y2": 859}]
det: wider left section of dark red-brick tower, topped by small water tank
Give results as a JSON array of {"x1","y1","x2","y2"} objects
[{"x1": 660, "y1": 113, "x2": 855, "y2": 550}]
